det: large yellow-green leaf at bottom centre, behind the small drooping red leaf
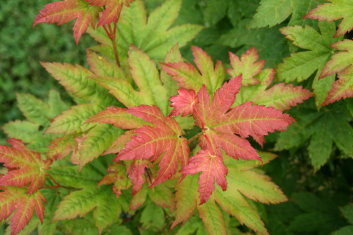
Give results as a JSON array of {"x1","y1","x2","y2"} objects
[{"x1": 173, "y1": 154, "x2": 287, "y2": 234}]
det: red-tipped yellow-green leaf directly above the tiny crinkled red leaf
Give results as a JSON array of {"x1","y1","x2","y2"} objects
[{"x1": 161, "y1": 46, "x2": 226, "y2": 93}]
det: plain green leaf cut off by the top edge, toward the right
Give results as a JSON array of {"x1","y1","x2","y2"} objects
[{"x1": 250, "y1": 0, "x2": 321, "y2": 27}]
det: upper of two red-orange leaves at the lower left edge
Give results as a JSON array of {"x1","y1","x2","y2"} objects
[{"x1": 0, "y1": 139, "x2": 49, "y2": 193}]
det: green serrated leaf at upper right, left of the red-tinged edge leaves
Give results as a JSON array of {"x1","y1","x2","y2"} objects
[{"x1": 277, "y1": 22, "x2": 340, "y2": 106}]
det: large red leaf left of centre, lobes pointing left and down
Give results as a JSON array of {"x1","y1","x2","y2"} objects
[{"x1": 116, "y1": 105, "x2": 190, "y2": 186}]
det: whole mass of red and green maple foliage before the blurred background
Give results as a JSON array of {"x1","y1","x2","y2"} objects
[{"x1": 0, "y1": 0, "x2": 353, "y2": 234}]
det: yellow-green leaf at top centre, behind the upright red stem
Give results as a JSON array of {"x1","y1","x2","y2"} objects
[{"x1": 89, "y1": 0, "x2": 202, "y2": 60}]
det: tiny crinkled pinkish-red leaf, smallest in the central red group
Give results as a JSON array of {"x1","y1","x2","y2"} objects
[{"x1": 170, "y1": 88, "x2": 197, "y2": 117}]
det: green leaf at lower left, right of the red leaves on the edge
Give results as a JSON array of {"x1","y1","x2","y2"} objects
[{"x1": 50, "y1": 164, "x2": 128, "y2": 232}]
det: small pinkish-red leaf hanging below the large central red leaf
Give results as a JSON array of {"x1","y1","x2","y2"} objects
[{"x1": 181, "y1": 150, "x2": 228, "y2": 204}]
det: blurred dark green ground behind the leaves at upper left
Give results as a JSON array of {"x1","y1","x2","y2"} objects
[{"x1": 0, "y1": 0, "x2": 93, "y2": 143}]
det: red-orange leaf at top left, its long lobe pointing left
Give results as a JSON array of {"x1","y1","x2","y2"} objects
[{"x1": 33, "y1": 0, "x2": 100, "y2": 43}]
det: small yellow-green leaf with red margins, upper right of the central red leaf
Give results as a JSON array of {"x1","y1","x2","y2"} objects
[{"x1": 227, "y1": 47, "x2": 265, "y2": 86}]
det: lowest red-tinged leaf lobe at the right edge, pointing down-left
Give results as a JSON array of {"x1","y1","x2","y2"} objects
[{"x1": 322, "y1": 64, "x2": 353, "y2": 105}]
